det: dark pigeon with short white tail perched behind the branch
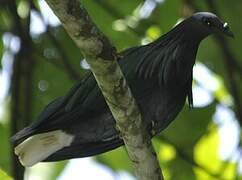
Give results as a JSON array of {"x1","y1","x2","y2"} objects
[{"x1": 12, "y1": 12, "x2": 233, "y2": 166}]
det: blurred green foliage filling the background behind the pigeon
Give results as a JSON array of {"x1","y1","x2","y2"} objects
[{"x1": 0, "y1": 0, "x2": 242, "y2": 180}]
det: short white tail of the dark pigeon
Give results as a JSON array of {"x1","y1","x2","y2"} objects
[{"x1": 14, "y1": 130, "x2": 74, "y2": 167}]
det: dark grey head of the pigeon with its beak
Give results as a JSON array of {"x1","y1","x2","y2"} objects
[{"x1": 191, "y1": 12, "x2": 234, "y2": 37}]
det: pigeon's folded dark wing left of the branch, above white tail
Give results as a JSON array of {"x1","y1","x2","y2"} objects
[{"x1": 12, "y1": 73, "x2": 104, "y2": 143}]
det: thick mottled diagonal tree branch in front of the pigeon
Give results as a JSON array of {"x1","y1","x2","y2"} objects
[{"x1": 46, "y1": 0, "x2": 162, "y2": 180}]
